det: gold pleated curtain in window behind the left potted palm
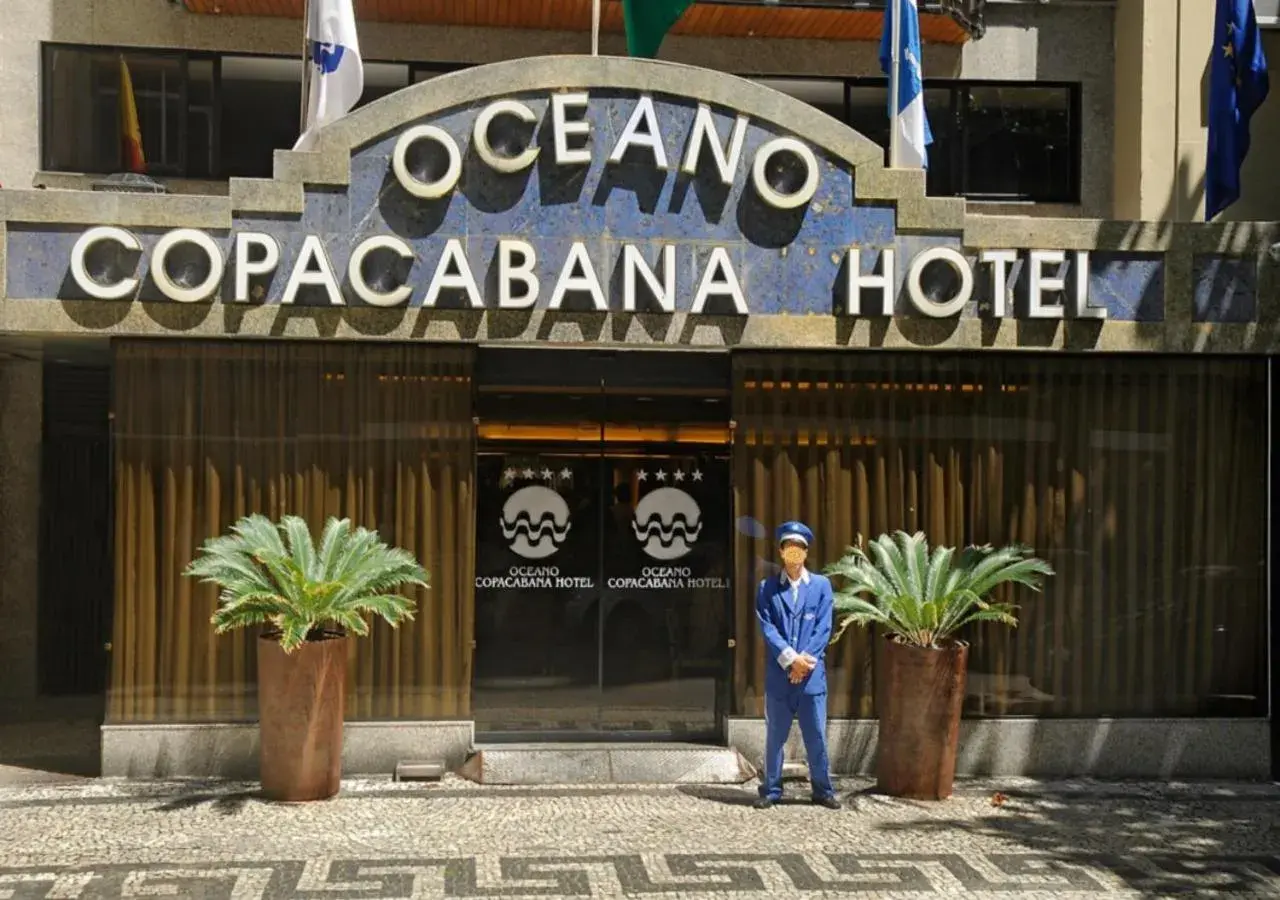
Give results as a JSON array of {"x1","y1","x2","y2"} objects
[{"x1": 109, "y1": 341, "x2": 474, "y2": 722}]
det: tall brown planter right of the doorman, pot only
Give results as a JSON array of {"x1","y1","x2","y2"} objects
[{"x1": 876, "y1": 638, "x2": 969, "y2": 800}]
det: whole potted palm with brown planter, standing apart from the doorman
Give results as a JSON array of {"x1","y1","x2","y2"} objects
[{"x1": 186, "y1": 515, "x2": 428, "y2": 801}]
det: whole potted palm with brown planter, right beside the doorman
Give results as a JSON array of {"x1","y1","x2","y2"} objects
[{"x1": 826, "y1": 531, "x2": 1053, "y2": 800}]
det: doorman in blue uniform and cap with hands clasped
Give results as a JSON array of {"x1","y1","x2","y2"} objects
[{"x1": 755, "y1": 522, "x2": 840, "y2": 809}]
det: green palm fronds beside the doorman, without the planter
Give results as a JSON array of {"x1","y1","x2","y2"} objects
[{"x1": 824, "y1": 531, "x2": 1053, "y2": 648}]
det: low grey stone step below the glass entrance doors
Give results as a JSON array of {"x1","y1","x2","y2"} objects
[{"x1": 458, "y1": 743, "x2": 756, "y2": 785}]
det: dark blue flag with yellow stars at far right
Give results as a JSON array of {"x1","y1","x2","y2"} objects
[{"x1": 1204, "y1": 0, "x2": 1271, "y2": 221}]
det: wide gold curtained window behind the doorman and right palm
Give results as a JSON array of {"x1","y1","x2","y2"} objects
[{"x1": 733, "y1": 353, "x2": 1267, "y2": 717}]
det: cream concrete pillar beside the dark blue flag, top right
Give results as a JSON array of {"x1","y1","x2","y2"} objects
[{"x1": 1111, "y1": 0, "x2": 1213, "y2": 221}]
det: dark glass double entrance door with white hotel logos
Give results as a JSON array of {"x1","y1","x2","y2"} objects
[{"x1": 472, "y1": 351, "x2": 732, "y2": 741}]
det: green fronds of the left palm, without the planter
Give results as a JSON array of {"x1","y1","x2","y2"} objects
[{"x1": 184, "y1": 515, "x2": 428, "y2": 653}]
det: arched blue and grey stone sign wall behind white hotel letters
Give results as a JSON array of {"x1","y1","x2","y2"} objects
[{"x1": 0, "y1": 56, "x2": 1280, "y2": 352}]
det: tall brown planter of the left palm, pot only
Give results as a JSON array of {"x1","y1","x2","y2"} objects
[{"x1": 257, "y1": 635, "x2": 348, "y2": 803}]
